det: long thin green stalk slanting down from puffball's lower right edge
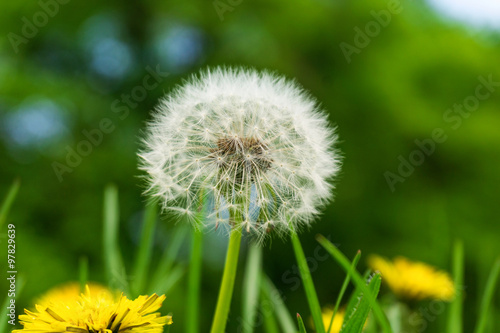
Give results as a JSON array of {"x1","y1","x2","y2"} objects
[{"x1": 291, "y1": 230, "x2": 325, "y2": 333}]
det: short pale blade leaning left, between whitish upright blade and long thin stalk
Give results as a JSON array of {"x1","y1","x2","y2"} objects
[{"x1": 260, "y1": 273, "x2": 297, "y2": 332}]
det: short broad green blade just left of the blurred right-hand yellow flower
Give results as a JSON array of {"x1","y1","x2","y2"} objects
[{"x1": 341, "y1": 274, "x2": 382, "y2": 333}]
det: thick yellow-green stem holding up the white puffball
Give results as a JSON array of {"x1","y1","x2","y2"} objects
[{"x1": 210, "y1": 226, "x2": 241, "y2": 333}]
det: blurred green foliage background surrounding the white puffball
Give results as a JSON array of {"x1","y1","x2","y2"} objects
[{"x1": 0, "y1": 0, "x2": 500, "y2": 332}]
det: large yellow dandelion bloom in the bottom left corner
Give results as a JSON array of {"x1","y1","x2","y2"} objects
[{"x1": 12, "y1": 286, "x2": 172, "y2": 333}]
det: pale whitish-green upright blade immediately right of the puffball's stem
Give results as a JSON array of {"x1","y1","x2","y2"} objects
[{"x1": 242, "y1": 242, "x2": 262, "y2": 333}]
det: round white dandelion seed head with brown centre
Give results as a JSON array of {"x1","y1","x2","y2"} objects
[{"x1": 139, "y1": 68, "x2": 340, "y2": 236}]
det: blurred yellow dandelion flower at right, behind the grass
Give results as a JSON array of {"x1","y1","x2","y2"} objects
[{"x1": 368, "y1": 255, "x2": 455, "y2": 301}]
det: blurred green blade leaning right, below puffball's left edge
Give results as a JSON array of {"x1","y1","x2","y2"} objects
[{"x1": 131, "y1": 201, "x2": 158, "y2": 296}]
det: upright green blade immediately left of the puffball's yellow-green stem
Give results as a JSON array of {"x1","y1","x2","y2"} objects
[{"x1": 186, "y1": 229, "x2": 203, "y2": 333}]
